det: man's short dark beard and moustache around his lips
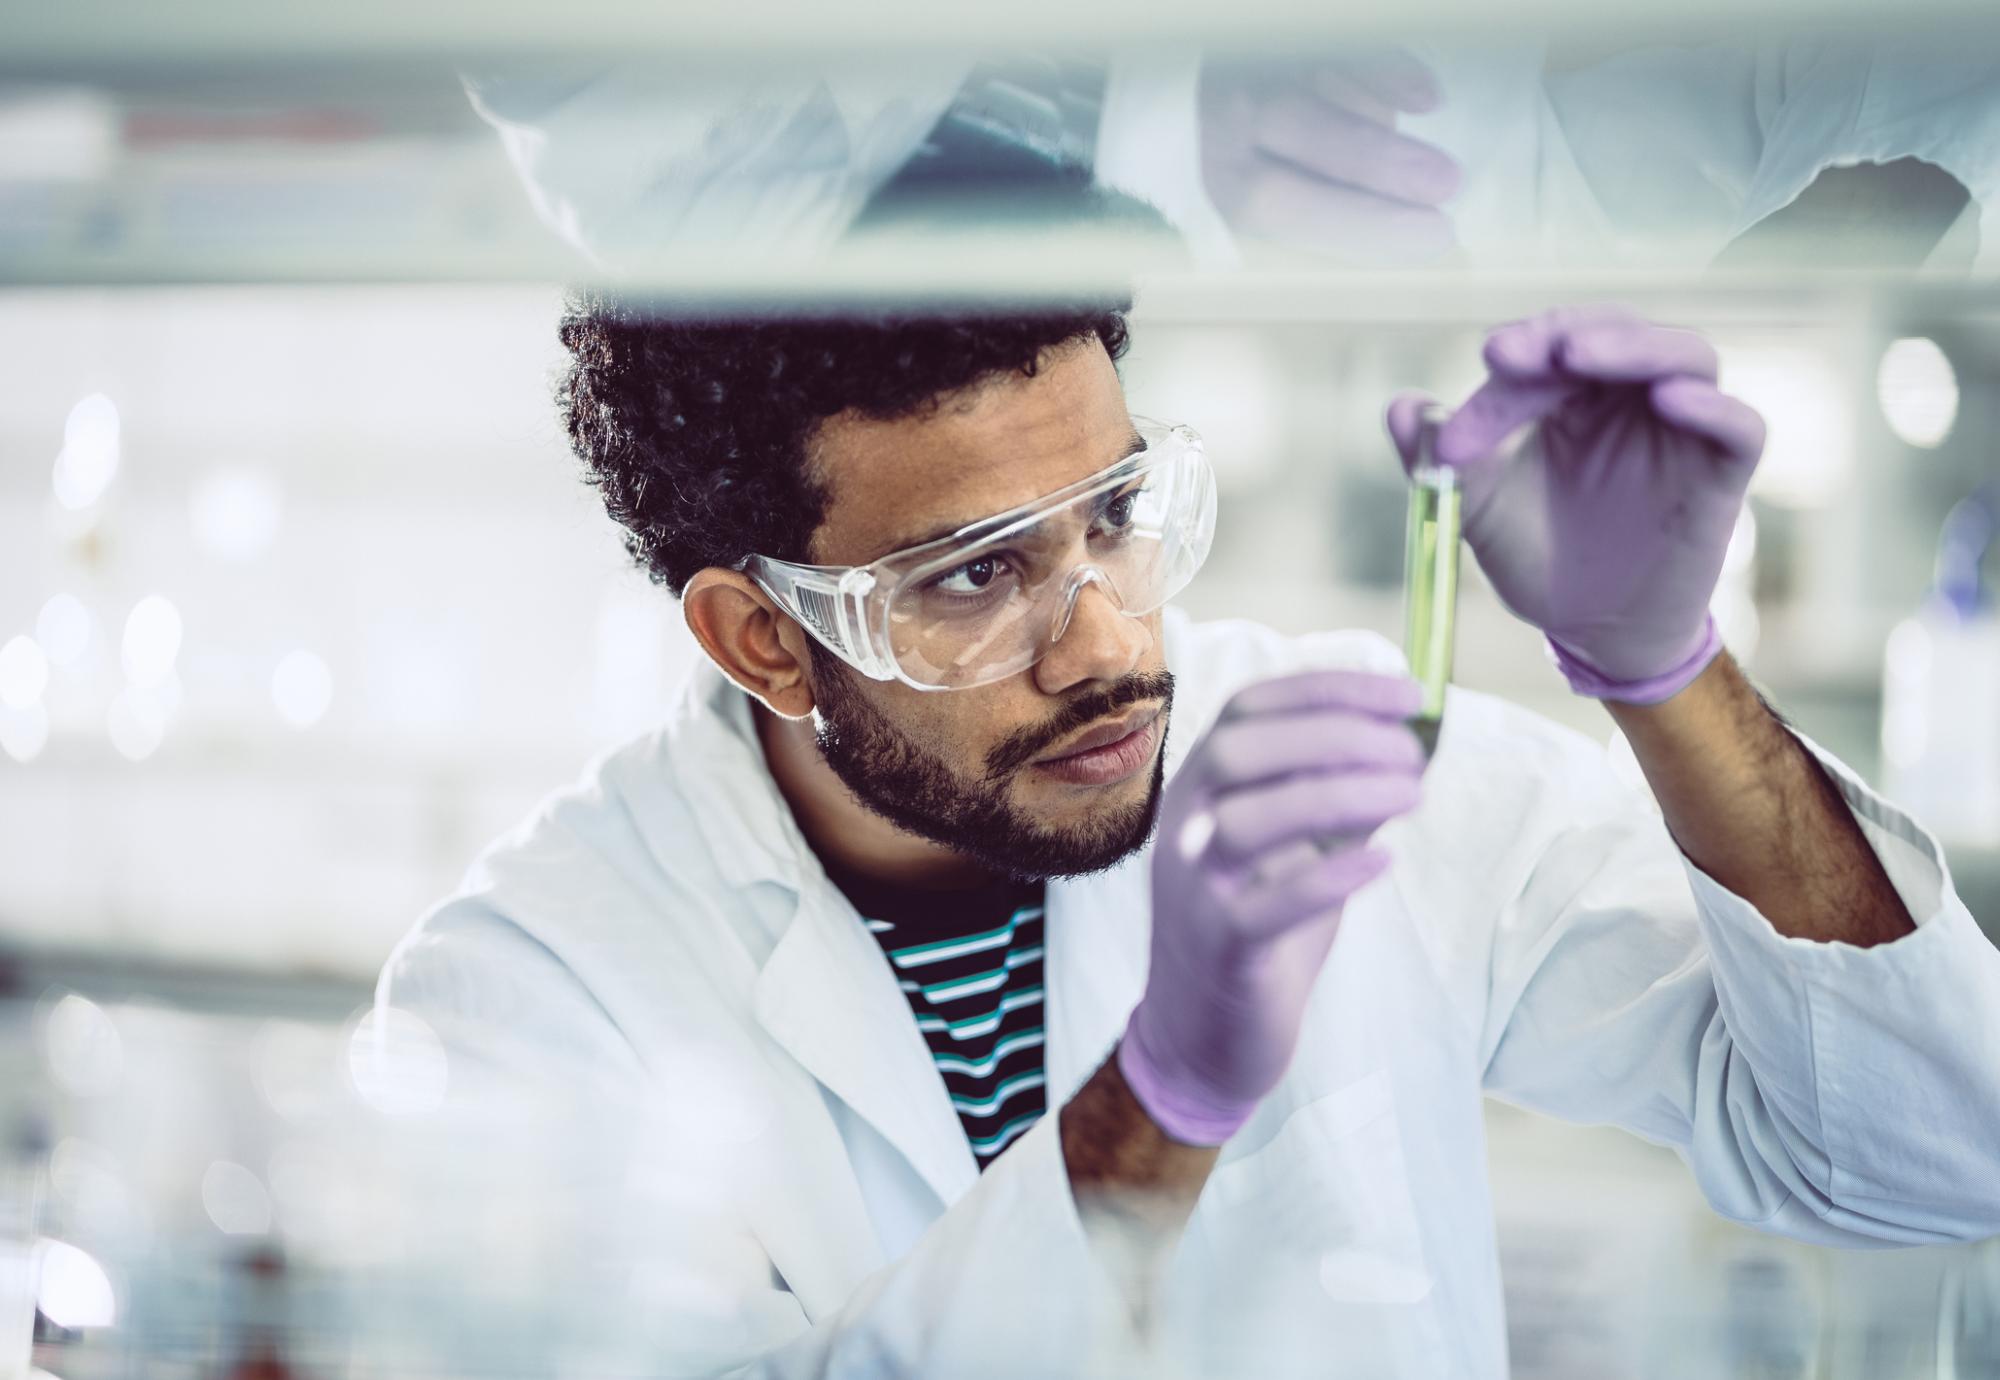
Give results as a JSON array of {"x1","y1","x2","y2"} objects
[{"x1": 812, "y1": 658, "x2": 1174, "y2": 880}]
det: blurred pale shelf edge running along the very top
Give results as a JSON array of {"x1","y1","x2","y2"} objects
[{"x1": 4, "y1": 0, "x2": 2000, "y2": 70}]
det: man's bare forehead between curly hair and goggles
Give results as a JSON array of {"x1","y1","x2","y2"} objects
[{"x1": 810, "y1": 336, "x2": 1132, "y2": 566}]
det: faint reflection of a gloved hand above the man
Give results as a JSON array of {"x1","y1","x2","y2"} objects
[{"x1": 1198, "y1": 48, "x2": 1460, "y2": 264}]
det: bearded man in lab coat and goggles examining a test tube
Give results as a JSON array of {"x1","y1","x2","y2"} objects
[{"x1": 382, "y1": 302, "x2": 2000, "y2": 1376}]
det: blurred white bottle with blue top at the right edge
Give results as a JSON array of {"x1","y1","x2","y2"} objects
[{"x1": 1882, "y1": 486, "x2": 2000, "y2": 846}]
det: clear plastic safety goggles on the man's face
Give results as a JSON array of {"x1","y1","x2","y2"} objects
[{"x1": 738, "y1": 418, "x2": 1216, "y2": 690}]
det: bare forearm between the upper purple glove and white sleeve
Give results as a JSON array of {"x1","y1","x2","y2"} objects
[{"x1": 1606, "y1": 654, "x2": 1916, "y2": 948}]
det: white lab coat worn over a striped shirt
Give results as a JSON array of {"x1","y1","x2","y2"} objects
[{"x1": 380, "y1": 610, "x2": 2000, "y2": 1376}]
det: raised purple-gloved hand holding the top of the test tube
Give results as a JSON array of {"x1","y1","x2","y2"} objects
[{"x1": 1388, "y1": 306, "x2": 1764, "y2": 704}]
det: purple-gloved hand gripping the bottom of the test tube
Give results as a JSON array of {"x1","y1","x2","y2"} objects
[{"x1": 1118, "y1": 670, "x2": 1424, "y2": 1146}]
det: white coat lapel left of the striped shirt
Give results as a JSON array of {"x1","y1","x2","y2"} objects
[{"x1": 756, "y1": 870, "x2": 978, "y2": 1204}]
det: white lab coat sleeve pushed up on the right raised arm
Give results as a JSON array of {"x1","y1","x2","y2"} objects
[{"x1": 1482, "y1": 724, "x2": 2000, "y2": 1246}]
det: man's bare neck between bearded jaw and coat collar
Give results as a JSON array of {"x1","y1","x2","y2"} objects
[{"x1": 750, "y1": 700, "x2": 992, "y2": 892}]
